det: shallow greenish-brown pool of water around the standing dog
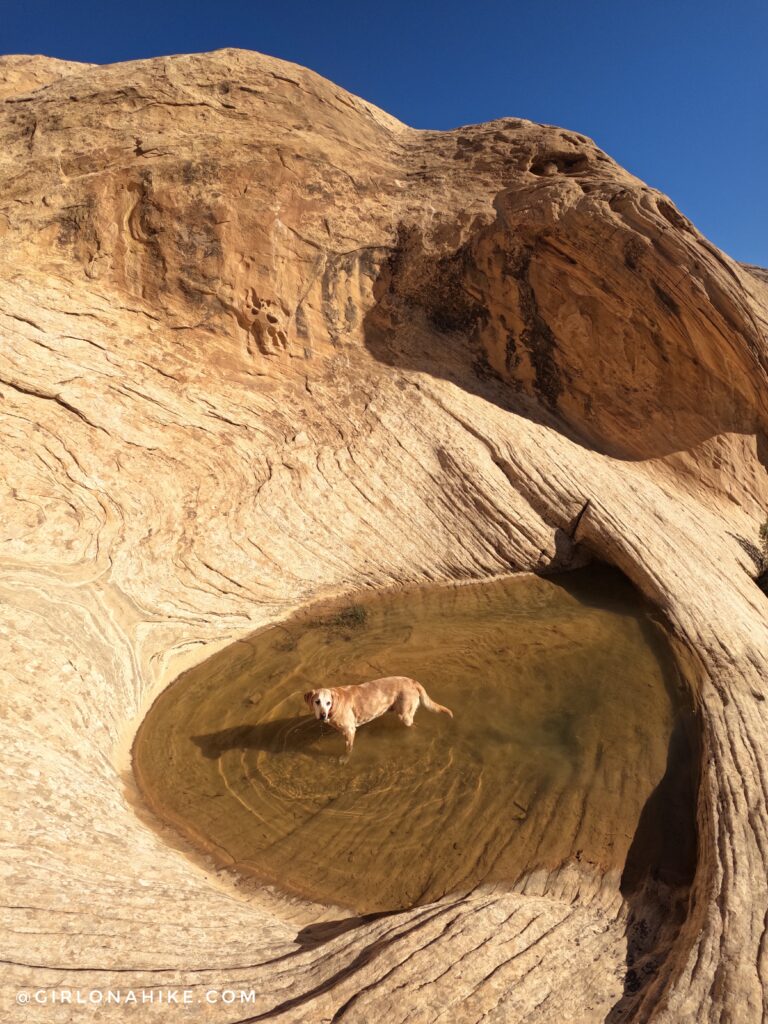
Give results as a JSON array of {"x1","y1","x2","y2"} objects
[{"x1": 133, "y1": 567, "x2": 692, "y2": 913}]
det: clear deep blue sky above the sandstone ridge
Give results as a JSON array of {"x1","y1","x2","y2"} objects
[{"x1": 0, "y1": 0, "x2": 768, "y2": 266}]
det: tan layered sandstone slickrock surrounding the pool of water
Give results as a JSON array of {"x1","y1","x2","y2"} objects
[{"x1": 0, "y1": 50, "x2": 768, "y2": 1024}]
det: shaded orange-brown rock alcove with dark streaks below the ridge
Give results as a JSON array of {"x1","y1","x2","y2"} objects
[{"x1": 364, "y1": 216, "x2": 768, "y2": 466}]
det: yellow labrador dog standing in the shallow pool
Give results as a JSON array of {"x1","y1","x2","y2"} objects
[{"x1": 304, "y1": 676, "x2": 454, "y2": 754}]
